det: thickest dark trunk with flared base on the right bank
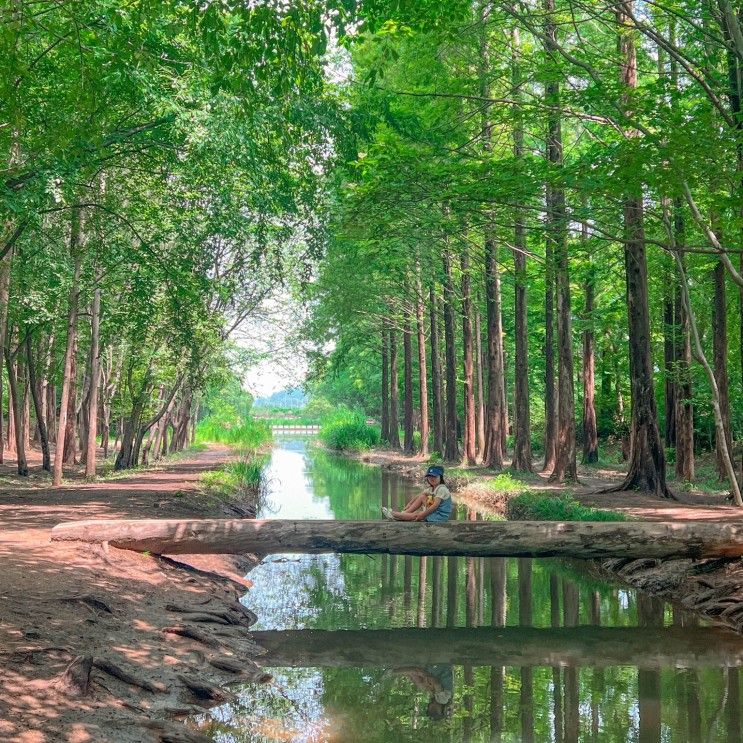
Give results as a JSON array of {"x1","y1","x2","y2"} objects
[{"x1": 617, "y1": 0, "x2": 673, "y2": 498}]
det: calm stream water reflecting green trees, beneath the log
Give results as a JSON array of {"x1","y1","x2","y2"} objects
[{"x1": 205, "y1": 439, "x2": 743, "y2": 743}]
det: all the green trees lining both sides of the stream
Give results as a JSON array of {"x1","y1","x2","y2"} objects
[{"x1": 0, "y1": 0, "x2": 743, "y2": 505}]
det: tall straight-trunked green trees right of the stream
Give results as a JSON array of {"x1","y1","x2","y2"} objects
[{"x1": 309, "y1": 0, "x2": 743, "y2": 505}]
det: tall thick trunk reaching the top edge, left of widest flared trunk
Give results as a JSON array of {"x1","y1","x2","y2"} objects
[{"x1": 544, "y1": 0, "x2": 578, "y2": 482}]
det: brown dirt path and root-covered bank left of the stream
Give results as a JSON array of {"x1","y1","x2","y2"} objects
[{"x1": 0, "y1": 448, "x2": 260, "y2": 743}]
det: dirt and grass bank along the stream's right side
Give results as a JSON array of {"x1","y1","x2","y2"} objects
[{"x1": 358, "y1": 450, "x2": 743, "y2": 633}]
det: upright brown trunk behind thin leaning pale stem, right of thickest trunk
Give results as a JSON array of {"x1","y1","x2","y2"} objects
[{"x1": 674, "y1": 218, "x2": 694, "y2": 482}]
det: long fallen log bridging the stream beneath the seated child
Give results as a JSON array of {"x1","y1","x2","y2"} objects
[{"x1": 52, "y1": 519, "x2": 743, "y2": 558}]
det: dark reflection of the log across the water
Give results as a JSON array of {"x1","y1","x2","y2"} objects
[{"x1": 252, "y1": 626, "x2": 743, "y2": 669}]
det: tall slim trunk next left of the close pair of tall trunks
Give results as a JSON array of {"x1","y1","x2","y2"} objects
[{"x1": 511, "y1": 27, "x2": 532, "y2": 472}]
